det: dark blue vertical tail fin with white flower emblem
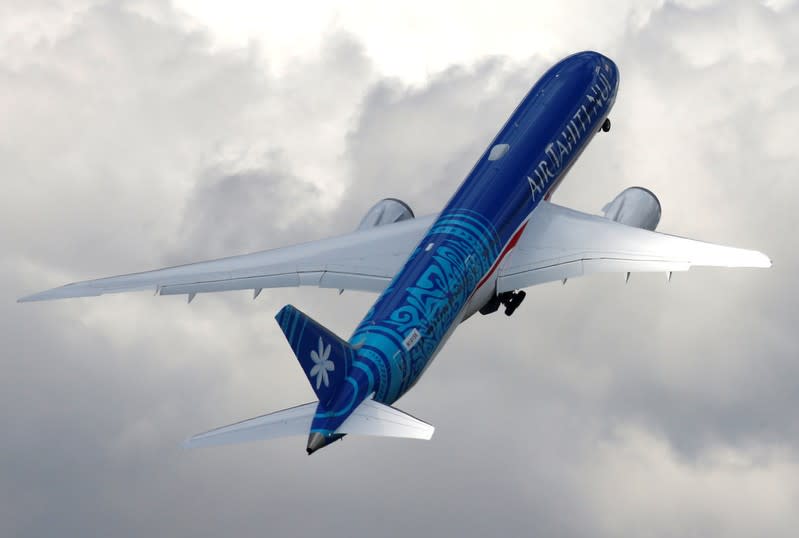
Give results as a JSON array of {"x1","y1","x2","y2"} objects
[{"x1": 275, "y1": 305, "x2": 355, "y2": 405}]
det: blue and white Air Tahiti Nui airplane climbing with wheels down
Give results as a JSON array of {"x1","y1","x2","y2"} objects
[{"x1": 19, "y1": 51, "x2": 771, "y2": 455}]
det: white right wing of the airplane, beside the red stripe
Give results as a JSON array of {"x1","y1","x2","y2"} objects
[{"x1": 497, "y1": 202, "x2": 771, "y2": 293}]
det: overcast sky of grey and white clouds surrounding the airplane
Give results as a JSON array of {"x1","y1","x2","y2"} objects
[{"x1": 0, "y1": 0, "x2": 799, "y2": 537}]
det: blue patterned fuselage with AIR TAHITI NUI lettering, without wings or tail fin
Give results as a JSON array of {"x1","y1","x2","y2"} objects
[{"x1": 312, "y1": 52, "x2": 619, "y2": 434}]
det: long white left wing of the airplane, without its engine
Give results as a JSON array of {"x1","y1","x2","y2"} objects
[{"x1": 19, "y1": 215, "x2": 435, "y2": 302}]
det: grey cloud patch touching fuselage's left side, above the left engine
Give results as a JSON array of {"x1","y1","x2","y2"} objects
[{"x1": 343, "y1": 58, "x2": 544, "y2": 214}]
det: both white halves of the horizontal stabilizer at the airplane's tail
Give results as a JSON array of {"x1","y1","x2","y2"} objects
[{"x1": 183, "y1": 399, "x2": 435, "y2": 448}]
